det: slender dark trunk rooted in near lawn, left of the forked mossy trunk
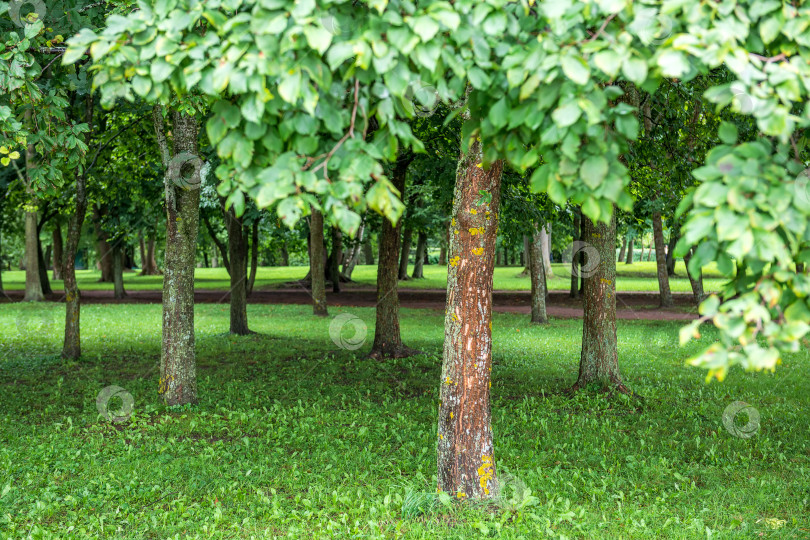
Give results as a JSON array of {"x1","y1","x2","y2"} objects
[{"x1": 62, "y1": 93, "x2": 93, "y2": 360}]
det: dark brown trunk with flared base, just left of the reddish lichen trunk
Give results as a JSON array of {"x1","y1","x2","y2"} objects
[{"x1": 369, "y1": 160, "x2": 416, "y2": 358}]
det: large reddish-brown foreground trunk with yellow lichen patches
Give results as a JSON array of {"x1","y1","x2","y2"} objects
[{"x1": 437, "y1": 137, "x2": 503, "y2": 499}]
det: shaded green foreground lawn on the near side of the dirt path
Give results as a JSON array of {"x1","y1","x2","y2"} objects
[{"x1": 0, "y1": 304, "x2": 810, "y2": 539}]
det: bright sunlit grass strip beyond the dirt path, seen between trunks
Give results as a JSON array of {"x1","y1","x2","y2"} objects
[{"x1": 3, "y1": 262, "x2": 723, "y2": 292}]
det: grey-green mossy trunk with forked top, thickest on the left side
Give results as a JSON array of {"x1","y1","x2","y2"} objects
[{"x1": 153, "y1": 106, "x2": 200, "y2": 405}]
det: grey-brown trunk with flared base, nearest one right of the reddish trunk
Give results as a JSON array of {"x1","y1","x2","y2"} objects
[{"x1": 574, "y1": 212, "x2": 630, "y2": 393}]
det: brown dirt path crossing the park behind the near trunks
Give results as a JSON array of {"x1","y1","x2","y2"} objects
[{"x1": 1, "y1": 287, "x2": 697, "y2": 321}]
